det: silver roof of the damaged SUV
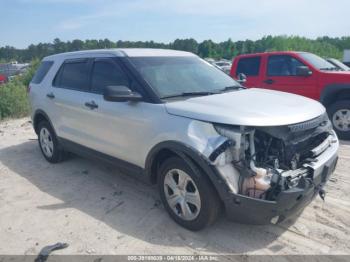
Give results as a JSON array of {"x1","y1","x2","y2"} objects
[{"x1": 43, "y1": 48, "x2": 195, "y2": 60}]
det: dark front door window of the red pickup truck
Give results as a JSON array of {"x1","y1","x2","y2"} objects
[{"x1": 267, "y1": 55, "x2": 305, "y2": 76}]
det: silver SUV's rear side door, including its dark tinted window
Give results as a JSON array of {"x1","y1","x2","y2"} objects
[{"x1": 47, "y1": 58, "x2": 91, "y2": 145}]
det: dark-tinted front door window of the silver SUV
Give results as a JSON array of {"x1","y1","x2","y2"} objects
[{"x1": 91, "y1": 59, "x2": 129, "y2": 94}]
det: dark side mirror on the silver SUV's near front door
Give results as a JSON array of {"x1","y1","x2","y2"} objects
[{"x1": 103, "y1": 86, "x2": 142, "y2": 102}]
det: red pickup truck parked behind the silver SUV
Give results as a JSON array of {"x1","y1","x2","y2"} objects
[{"x1": 230, "y1": 52, "x2": 350, "y2": 139}]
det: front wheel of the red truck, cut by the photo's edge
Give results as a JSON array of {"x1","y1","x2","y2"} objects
[{"x1": 327, "y1": 100, "x2": 350, "y2": 140}]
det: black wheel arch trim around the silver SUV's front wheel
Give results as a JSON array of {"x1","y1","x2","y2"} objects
[{"x1": 145, "y1": 141, "x2": 229, "y2": 200}]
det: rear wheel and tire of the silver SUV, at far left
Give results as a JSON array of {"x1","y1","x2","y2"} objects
[{"x1": 38, "y1": 121, "x2": 64, "y2": 163}]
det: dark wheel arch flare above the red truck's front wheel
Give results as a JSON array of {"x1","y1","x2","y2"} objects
[{"x1": 320, "y1": 84, "x2": 350, "y2": 107}]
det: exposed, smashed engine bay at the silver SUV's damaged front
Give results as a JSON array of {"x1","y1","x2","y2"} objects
[{"x1": 209, "y1": 114, "x2": 336, "y2": 201}]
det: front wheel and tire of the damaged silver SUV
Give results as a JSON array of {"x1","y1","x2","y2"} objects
[{"x1": 159, "y1": 157, "x2": 221, "y2": 231}]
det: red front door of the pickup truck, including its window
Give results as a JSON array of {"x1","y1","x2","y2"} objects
[{"x1": 261, "y1": 55, "x2": 317, "y2": 99}]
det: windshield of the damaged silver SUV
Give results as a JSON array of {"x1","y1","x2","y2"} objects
[{"x1": 130, "y1": 56, "x2": 241, "y2": 98}]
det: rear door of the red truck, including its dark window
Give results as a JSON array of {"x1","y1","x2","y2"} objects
[{"x1": 235, "y1": 56, "x2": 261, "y2": 87}]
